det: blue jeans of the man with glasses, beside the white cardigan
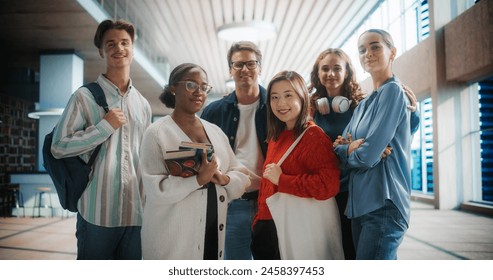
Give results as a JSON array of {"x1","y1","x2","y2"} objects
[{"x1": 224, "y1": 199, "x2": 257, "y2": 260}]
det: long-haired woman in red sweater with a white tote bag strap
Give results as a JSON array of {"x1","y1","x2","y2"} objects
[{"x1": 251, "y1": 71, "x2": 340, "y2": 259}]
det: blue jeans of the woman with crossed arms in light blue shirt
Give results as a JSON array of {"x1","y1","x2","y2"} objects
[{"x1": 351, "y1": 200, "x2": 407, "y2": 260}]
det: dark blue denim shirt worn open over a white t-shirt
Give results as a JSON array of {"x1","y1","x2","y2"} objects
[{"x1": 200, "y1": 85, "x2": 267, "y2": 158}]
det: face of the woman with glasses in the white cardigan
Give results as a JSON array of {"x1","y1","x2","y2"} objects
[{"x1": 170, "y1": 68, "x2": 208, "y2": 114}]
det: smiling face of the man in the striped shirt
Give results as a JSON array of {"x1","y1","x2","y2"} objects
[{"x1": 99, "y1": 29, "x2": 133, "y2": 69}]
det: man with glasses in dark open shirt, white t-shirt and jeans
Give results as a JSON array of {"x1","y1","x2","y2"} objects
[{"x1": 201, "y1": 41, "x2": 267, "y2": 260}]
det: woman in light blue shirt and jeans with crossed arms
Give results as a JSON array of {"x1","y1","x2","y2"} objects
[{"x1": 334, "y1": 29, "x2": 411, "y2": 259}]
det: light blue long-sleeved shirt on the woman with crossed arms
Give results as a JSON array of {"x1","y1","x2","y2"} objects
[{"x1": 335, "y1": 77, "x2": 411, "y2": 224}]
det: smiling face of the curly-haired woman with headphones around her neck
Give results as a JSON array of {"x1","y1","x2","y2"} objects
[{"x1": 318, "y1": 53, "x2": 348, "y2": 97}]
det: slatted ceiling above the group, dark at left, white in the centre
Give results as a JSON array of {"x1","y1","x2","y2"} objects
[{"x1": 0, "y1": 0, "x2": 382, "y2": 114}]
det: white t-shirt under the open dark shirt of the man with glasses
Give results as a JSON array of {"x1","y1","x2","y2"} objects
[{"x1": 235, "y1": 100, "x2": 264, "y2": 192}]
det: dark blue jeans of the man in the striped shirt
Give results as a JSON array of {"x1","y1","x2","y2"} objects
[{"x1": 75, "y1": 213, "x2": 142, "y2": 260}]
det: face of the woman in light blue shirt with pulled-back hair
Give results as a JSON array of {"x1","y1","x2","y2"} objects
[{"x1": 358, "y1": 32, "x2": 396, "y2": 75}]
